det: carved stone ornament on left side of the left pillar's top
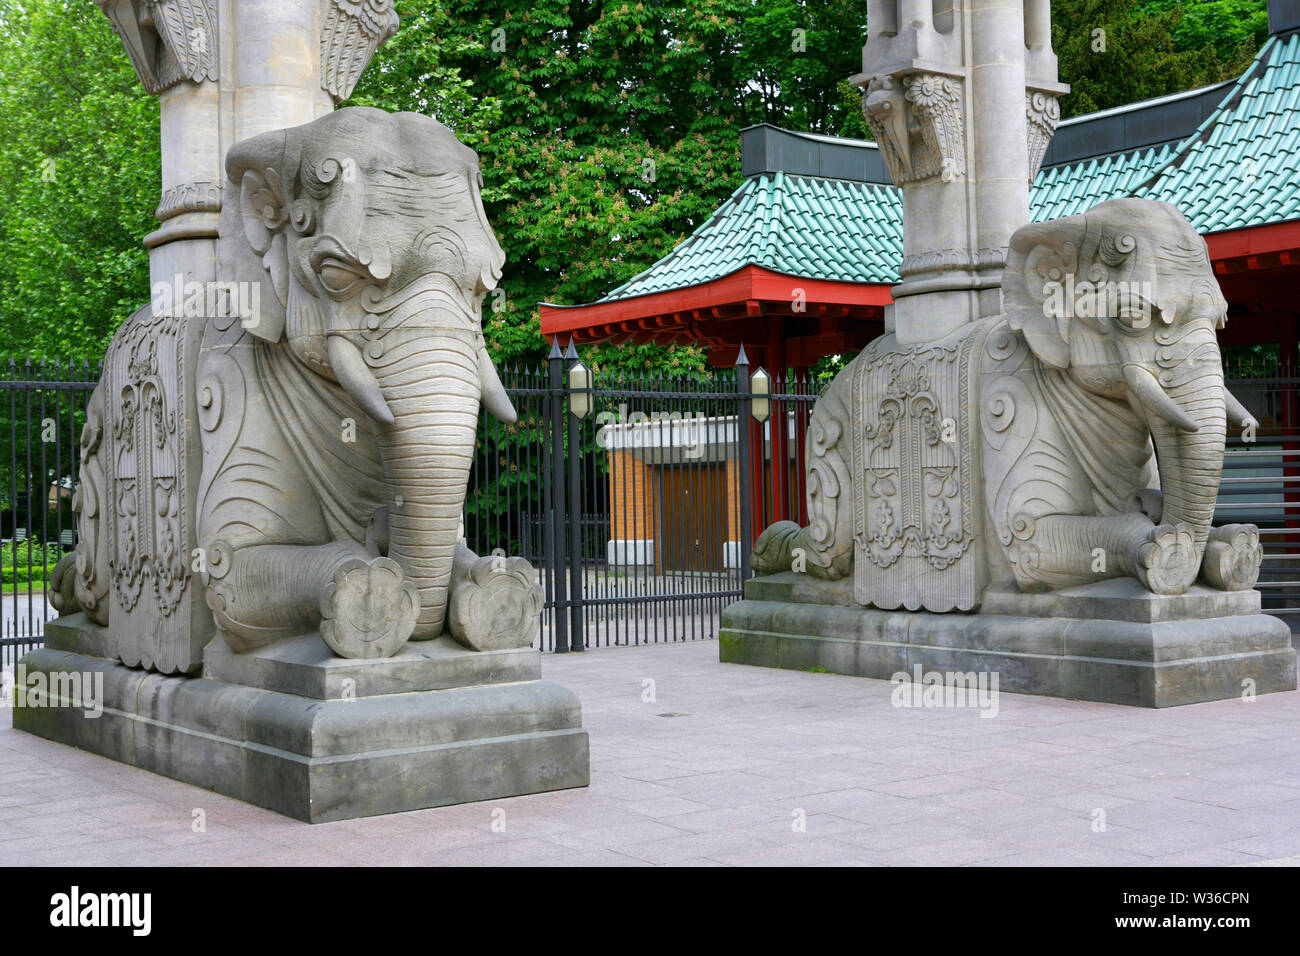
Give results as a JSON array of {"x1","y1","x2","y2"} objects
[{"x1": 95, "y1": 0, "x2": 217, "y2": 94}]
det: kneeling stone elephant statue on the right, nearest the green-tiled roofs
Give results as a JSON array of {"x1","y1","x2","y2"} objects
[{"x1": 753, "y1": 199, "x2": 1261, "y2": 611}]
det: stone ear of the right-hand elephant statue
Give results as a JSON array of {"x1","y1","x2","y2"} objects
[{"x1": 1002, "y1": 216, "x2": 1087, "y2": 368}]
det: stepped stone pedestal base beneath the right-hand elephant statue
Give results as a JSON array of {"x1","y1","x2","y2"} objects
[{"x1": 719, "y1": 571, "x2": 1296, "y2": 708}]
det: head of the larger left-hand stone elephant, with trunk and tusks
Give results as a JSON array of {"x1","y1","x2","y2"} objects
[{"x1": 221, "y1": 107, "x2": 515, "y2": 637}]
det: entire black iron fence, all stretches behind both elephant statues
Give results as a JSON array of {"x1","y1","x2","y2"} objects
[{"x1": 0, "y1": 347, "x2": 1300, "y2": 665}]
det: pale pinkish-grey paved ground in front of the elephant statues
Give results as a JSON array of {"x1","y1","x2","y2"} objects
[{"x1": 0, "y1": 641, "x2": 1300, "y2": 866}]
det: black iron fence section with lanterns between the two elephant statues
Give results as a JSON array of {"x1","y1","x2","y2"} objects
[{"x1": 496, "y1": 346, "x2": 815, "y2": 652}]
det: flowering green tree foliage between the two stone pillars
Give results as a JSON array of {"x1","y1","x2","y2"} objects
[{"x1": 354, "y1": 0, "x2": 862, "y2": 373}]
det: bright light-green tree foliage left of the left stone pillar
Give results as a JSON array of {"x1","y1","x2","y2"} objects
[{"x1": 0, "y1": 0, "x2": 160, "y2": 359}]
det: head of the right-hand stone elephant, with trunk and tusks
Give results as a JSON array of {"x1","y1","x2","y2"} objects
[{"x1": 1002, "y1": 199, "x2": 1253, "y2": 574}]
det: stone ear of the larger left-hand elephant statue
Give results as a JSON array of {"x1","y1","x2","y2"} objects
[{"x1": 217, "y1": 130, "x2": 298, "y2": 342}]
